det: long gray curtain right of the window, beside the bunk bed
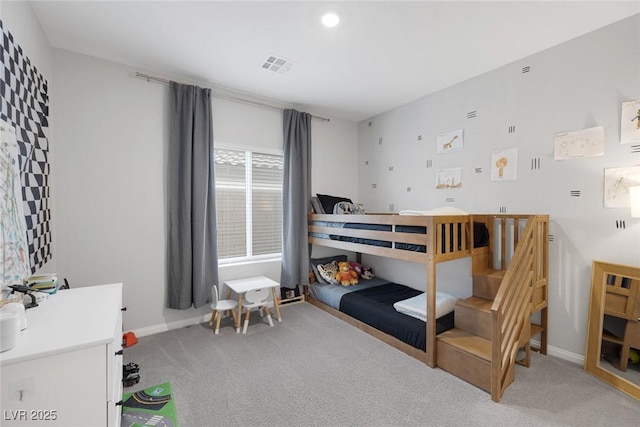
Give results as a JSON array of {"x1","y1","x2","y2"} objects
[{"x1": 280, "y1": 110, "x2": 311, "y2": 289}]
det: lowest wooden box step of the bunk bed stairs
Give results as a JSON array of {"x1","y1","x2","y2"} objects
[{"x1": 436, "y1": 328, "x2": 491, "y2": 393}]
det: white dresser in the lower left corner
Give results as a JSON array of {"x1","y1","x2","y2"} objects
[{"x1": 0, "y1": 283, "x2": 122, "y2": 427}]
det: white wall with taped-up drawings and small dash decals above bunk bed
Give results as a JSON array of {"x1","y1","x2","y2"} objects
[{"x1": 359, "y1": 15, "x2": 640, "y2": 359}]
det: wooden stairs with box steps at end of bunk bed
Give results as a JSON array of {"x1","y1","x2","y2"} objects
[{"x1": 436, "y1": 216, "x2": 547, "y2": 401}]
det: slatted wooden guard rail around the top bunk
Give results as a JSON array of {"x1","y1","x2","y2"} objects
[{"x1": 309, "y1": 214, "x2": 472, "y2": 263}]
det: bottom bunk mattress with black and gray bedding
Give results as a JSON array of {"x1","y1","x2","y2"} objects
[{"x1": 311, "y1": 277, "x2": 454, "y2": 351}]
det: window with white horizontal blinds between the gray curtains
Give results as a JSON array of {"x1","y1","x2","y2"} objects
[{"x1": 214, "y1": 148, "x2": 283, "y2": 263}]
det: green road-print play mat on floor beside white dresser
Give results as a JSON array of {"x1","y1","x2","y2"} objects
[{"x1": 122, "y1": 383, "x2": 178, "y2": 427}]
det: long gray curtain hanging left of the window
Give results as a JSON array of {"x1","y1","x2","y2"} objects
[{"x1": 167, "y1": 82, "x2": 218, "y2": 309}]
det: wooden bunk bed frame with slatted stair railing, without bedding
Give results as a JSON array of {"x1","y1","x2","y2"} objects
[{"x1": 307, "y1": 214, "x2": 549, "y2": 401}]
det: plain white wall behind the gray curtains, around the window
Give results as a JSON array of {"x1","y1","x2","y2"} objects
[{"x1": 48, "y1": 50, "x2": 357, "y2": 332}]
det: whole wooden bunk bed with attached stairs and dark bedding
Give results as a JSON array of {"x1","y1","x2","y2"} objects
[{"x1": 305, "y1": 209, "x2": 549, "y2": 401}]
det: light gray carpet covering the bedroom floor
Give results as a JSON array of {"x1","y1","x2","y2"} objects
[{"x1": 124, "y1": 303, "x2": 640, "y2": 427}]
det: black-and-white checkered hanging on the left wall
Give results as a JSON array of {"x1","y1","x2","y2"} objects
[{"x1": 0, "y1": 20, "x2": 52, "y2": 273}]
